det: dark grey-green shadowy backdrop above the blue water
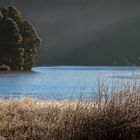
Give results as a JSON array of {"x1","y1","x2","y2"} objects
[{"x1": 0, "y1": 0, "x2": 140, "y2": 65}]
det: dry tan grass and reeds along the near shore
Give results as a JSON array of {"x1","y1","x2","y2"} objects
[{"x1": 0, "y1": 88, "x2": 140, "y2": 140}]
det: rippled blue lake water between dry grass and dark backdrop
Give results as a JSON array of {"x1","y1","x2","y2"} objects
[{"x1": 0, "y1": 66, "x2": 140, "y2": 100}]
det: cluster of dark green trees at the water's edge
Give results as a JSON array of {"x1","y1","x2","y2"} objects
[{"x1": 0, "y1": 5, "x2": 40, "y2": 70}]
